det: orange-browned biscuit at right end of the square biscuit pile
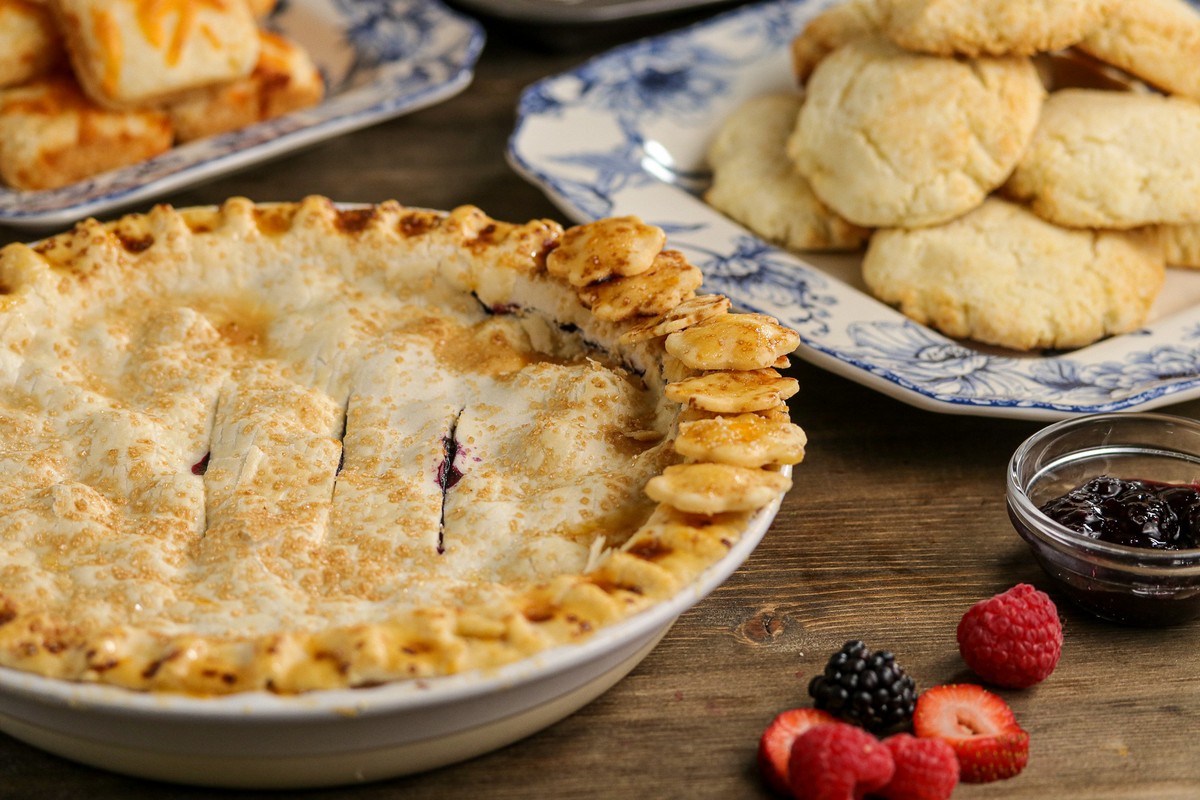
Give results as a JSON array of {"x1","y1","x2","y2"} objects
[{"x1": 167, "y1": 31, "x2": 325, "y2": 142}]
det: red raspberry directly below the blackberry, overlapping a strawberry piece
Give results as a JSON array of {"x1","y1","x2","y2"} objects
[{"x1": 787, "y1": 722, "x2": 895, "y2": 800}]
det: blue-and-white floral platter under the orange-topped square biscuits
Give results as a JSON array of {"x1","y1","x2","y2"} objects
[{"x1": 0, "y1": 0, "x2": 484, "y2": 228}]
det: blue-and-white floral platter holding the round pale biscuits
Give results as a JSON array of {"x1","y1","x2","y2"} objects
[{"x1": 508, "y1": 0, "x2": 1200, "y2": 419}]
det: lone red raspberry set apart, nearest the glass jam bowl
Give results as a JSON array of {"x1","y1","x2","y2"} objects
[{"x1": 958, "y1": 583, "x2": 1062, "y2": 688}]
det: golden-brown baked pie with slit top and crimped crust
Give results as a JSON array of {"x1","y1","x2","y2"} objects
[{"x1": 0, "y1": 197, "x2": 805, "y2": 696}]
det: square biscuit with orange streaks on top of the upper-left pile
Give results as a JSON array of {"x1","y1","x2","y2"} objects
[{"x1": 52, "y1": 0, "x2": 259, "y2": 108}]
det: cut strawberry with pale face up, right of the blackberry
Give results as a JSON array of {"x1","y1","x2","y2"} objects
[{"x1": 912, "y1": 684, "x2": 1030, "y2": 783}]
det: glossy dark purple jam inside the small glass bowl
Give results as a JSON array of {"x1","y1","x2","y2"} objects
[{"x1": 1042, "y1": 475, "x2": 1200, "y2": 551}]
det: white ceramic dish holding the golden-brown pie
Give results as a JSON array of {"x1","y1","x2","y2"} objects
[{"x1": 0, "y1": 468, "x2": 791, "y2": 789}]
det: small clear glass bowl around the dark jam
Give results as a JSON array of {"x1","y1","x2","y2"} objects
[{"x1": 1007, "y1": 414, "x2": 1200, "y2": 626}]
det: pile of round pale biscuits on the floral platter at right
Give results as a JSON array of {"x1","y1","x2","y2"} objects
[{"x1": 707, "y1": 0, "x2": 1200, "y2": 350}]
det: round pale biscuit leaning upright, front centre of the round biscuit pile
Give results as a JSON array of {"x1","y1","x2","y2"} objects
[{"x1": 787, "y1": 37, "x2": 1045, "y2": 228}]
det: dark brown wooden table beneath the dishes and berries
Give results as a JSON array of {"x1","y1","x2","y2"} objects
[{"x1": 0, "y1": 7, "x2": 1200, "y2": 800}]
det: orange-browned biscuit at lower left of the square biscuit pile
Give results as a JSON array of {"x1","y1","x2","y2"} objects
[{"x1": 0, "y1": 76, "x2": 172, "y2": 190}]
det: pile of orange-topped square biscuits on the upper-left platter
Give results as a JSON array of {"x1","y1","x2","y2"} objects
[{"x1": 0, "y1": 0, "x2": 324, "y2": 190}]
